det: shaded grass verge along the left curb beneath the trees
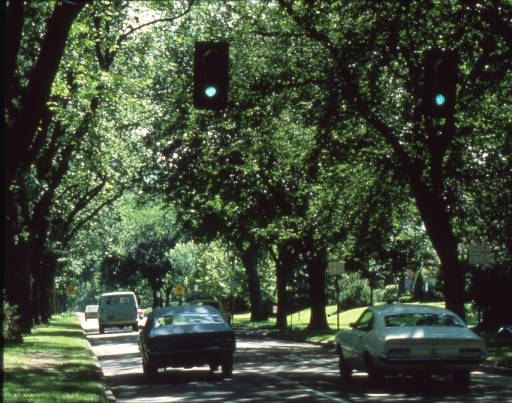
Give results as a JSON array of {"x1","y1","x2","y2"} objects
[{"x1": 3, "y1": 314, "x2": 108, "y2": 403}]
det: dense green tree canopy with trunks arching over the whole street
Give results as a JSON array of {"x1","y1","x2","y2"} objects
[{"x1": 3, "y1": 0, "x2": 512, "y2": 338}]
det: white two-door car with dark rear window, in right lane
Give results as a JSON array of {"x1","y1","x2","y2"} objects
[{"x1": 335, "y1": 304, "x2": 486, "y2": 387}]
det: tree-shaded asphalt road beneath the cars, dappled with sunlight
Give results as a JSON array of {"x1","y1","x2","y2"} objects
[{"x1": 77, "y1": 317, "x2": 512, "y2": 403}]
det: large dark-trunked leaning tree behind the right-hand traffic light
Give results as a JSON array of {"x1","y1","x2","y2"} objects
[{"x1": 279, "y1": 0, "x2": 511, "y2": 322}]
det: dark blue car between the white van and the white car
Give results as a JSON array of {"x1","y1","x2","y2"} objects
[{"x1": 139, "y1": 305, "x2": 236, "y2": 378}]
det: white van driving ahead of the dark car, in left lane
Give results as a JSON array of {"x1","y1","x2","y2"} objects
[{"x1": 98, "y1": 291, "x2": 139, "y2": 333}]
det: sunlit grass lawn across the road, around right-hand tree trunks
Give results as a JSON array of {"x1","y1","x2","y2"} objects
[{"x1": 232, "y1": 301, "x2": 512, "y2": 368}]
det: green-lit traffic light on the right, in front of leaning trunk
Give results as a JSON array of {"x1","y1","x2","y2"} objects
[{"x1": 423, "y1": 49, "x2": 457, "y2": 118}]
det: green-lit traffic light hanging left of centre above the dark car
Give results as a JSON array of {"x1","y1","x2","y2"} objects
[{"x1": 194, "y1": 42, "x2": 229, "y2": 110}]
